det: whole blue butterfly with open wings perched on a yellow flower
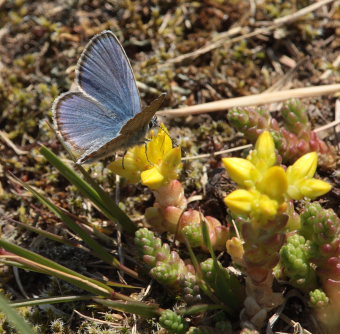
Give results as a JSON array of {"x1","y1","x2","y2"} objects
[{"x1": 52, "y1": 31, "x2": 166, "y2": 164}]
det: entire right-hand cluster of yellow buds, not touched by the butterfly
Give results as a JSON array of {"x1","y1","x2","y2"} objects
[{"x1": 223, "y1": 131, "x2": 331, "y2": 223}]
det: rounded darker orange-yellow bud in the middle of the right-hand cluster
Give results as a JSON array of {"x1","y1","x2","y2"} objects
[{"x1": 256, "y1": 166, "x2": 288, "y2": 202}]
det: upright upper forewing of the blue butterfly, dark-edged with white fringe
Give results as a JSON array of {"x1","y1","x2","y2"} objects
[{"x1": 77, "y1": 31, "x2": 141, "y2": 119}]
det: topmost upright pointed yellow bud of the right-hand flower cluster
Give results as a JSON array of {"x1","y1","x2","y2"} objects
[{"x1": 247, "y1": 131, "x2": 276, "y2": 171}]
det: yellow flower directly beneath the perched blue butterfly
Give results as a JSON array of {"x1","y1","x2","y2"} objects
[{"x1": 109, "y1": 124, "x2": 182, "y2": 189}]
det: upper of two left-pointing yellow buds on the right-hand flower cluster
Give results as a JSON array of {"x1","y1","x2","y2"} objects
[{"x1": 222, "y1": 158, "x2": 258, "y2": 188}]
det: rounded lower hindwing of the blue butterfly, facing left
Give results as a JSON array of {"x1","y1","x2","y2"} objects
[{"x1": 53, "y1": 92, "x2": 122, "y2": 152}]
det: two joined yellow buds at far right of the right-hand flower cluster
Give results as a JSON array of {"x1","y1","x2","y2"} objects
[{"x1": 287, "y1": 152, "x2": 332, "y2": 200}]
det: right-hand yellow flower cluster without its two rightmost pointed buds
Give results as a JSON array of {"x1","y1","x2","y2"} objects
[{"x1": 223, "y1": 131, "x2": 288, "y2": 223}]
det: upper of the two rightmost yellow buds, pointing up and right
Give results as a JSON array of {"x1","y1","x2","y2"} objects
[{"x1": 287, "y1": 152, "x2": 318, "y2": 184}]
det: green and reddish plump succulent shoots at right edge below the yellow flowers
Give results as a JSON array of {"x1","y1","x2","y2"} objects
[{"x1": 281, "y1": 203, "x2": 340, "y2": 327}]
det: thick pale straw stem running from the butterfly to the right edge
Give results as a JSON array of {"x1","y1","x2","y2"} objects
[{"x1": 157, "y1": 84, "x2": 340, "y2": 117}]
